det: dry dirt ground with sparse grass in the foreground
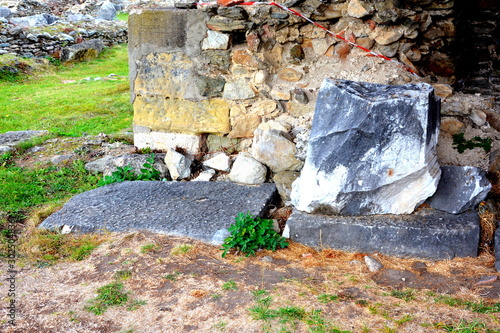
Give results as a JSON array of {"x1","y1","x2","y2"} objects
[{"x1": 0, "y1": 232, "x2": 500, "y2": 333}]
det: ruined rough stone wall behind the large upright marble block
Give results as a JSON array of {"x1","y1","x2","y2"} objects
[{"x1": 129, "y1": 0, "x2": 456, "y2": 151}]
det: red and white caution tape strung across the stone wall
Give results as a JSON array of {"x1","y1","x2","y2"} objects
[{"x1": 196, "y1": 0, "x2": 418, "y2": 75}]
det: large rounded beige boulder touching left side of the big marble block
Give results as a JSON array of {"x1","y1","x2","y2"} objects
[{"x1": 252, "y1": 129, "x2": 302, "y2": 172}]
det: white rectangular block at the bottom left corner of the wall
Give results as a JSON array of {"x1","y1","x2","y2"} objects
[{"x1": 134, "y1": 130, "x2": 201, "y2": 155}]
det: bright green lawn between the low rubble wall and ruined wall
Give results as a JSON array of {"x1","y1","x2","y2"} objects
[{"x1": 0, "y1": 45, "x2": 133, "y2": 136}]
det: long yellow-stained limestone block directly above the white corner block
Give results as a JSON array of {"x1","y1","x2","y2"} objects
[{"x1": 134, "y1": 96, "x2": 230, "y2": 135}]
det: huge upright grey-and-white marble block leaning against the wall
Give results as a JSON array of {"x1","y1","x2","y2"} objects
[{"x1": 292, "y1": 79, "x2": 440, "y2": 215}]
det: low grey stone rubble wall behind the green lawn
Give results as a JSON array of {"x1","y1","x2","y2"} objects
[{"x1": 0, "y1": 0, "x2": 127, "y2": 58}]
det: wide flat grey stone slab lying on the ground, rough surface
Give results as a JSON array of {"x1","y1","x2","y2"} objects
[{"x1": 40, "y1": 181, "x2": 277, "y2": 245}]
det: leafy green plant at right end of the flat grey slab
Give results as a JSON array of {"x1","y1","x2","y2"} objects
[{"x1": 221, "y1": 213, "x2": 288, "y2": 258}]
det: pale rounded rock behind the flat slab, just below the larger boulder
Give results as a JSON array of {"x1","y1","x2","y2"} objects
[{"x1": 229, "y1": 153, "x2": 267, "y2": 185}]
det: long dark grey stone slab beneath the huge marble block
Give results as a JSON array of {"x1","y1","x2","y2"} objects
[{"x1": 287, "y1": 209, "x2": 480, "y2": 260}]
